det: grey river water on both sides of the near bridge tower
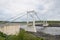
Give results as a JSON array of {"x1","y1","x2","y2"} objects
[{"x1": 21, "y1": 25, "x2": 60, "y2": 35}]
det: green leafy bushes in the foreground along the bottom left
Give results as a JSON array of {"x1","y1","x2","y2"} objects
[{"x1": 0, "y1": 30, "x2": 43, "y2": 40}]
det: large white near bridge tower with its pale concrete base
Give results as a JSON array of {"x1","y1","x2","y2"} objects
[{"x1": 26, "y1": 11, "x2": 36, "y2": 32}]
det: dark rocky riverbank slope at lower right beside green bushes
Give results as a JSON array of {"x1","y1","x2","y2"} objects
[{"x1": 29, "y1": 32, "x2": 60, "y2": 40}]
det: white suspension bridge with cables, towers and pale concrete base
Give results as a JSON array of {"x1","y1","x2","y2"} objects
[{"x1": 0, "y1": 10, "x2": 48, "y2": 32}]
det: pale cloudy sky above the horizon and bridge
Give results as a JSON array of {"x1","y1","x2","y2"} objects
[{"x1": 0, "y1": 0, "x2": 60, "y2": 21}]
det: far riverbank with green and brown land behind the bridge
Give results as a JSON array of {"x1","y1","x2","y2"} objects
[{"x1": 0, "y1": 21, "x2": 60, "y2": 27}]
